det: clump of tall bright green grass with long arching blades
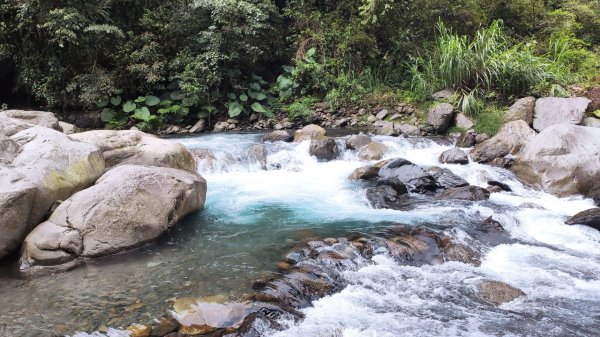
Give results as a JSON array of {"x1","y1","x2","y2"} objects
[{"x1": 408, "y1": 20, "x2": 570, "y2": 114}]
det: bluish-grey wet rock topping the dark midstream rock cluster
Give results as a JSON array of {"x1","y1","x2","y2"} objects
[{"x1": 379, "y1": 158, "x2": 468, "y2": 193}]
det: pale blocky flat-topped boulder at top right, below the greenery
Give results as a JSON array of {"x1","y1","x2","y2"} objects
[{"x1": 533, "y1": 97, "x2": 592, "y2": 131}]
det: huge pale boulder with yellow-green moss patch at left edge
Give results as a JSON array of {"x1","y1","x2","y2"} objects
[{"x1": 0, "y1": 116, "x2": 105, "y2": 257}]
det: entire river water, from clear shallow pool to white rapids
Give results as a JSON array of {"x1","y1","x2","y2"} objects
[{"x1": 0, "y1": 134, "x2": 600, "y2": 337}]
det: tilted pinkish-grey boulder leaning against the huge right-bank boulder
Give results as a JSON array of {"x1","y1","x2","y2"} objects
[{"x1": 470, "y1": 120, "x2": 536, "y2": 163}]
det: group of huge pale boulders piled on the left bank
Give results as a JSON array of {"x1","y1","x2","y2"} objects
[{"x1": 0, "y1": 110, "x2": 206, "y2": 274}]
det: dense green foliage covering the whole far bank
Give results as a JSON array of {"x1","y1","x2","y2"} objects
[{"x1": 0, "y1": 0, "x2": 600, "y2": 128}]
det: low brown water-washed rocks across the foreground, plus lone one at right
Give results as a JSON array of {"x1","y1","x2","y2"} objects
[{"x1": 120, "y1": 220, "x2": 526, "y2": 337}]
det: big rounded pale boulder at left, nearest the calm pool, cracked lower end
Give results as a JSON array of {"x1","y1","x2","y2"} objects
[{"x1": 19, "y1": 165, "x2": 206, "y2": 274}]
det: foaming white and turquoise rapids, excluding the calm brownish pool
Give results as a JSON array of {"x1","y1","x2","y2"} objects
[{"x1": 71, "y1": 134, "x2": 600, "y2": 337}]
